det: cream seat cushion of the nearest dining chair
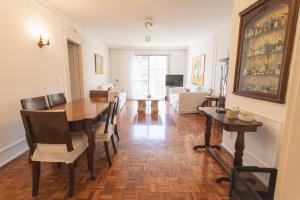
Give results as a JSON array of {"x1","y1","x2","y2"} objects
[{"x1": 31, "y1": 131, "x2": 89, "y2": 163}]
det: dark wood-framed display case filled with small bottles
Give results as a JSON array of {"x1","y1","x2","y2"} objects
[{"x1": 233, "y1": 0, "x2": 299, "y2": 103}]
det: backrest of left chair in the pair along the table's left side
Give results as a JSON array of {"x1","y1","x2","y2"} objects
[{"x1": 20, "y1": 96, "x2": 49, "y2": 110}]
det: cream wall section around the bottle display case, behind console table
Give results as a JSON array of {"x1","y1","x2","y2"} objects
[{"x1": 223, "y1": 0, "x2": 300, "y2": 170}]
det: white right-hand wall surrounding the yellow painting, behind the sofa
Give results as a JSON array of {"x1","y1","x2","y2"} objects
[{"x1": 187, "y1": 20, "x2": 231, "y2": 95}]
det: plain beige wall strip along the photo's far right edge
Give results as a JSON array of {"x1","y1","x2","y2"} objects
[{"x1": 275, "y1": 33, "x2": 300, "y2": 200}]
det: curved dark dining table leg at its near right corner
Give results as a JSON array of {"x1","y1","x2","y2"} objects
[{"x1": 83, "y1": 120, "x2": 96, "y2": 180}]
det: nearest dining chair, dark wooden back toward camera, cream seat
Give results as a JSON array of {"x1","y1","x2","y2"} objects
[{"x1": 20, "y1": 110, "x2": 88, "y2": 196}]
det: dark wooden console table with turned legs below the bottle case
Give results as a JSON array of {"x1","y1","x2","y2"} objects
[{"x1": 194, "y1": 107, "x2": 263, "y2": 182}]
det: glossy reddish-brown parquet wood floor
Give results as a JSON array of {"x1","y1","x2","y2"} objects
[{"x1": 0, "y1": 102, "x2": 229, "y2": 200}]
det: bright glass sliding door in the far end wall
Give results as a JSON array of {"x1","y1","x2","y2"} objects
[{"x1": 133, "y1": 55, "x2": 168, "y2": 98}]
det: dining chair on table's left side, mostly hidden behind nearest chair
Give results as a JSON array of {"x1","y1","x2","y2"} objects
[{"x1": 20, "y1": 96, "x2": 49, "y2": 163}]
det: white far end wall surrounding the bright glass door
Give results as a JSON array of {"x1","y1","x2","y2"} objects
[{"x1": 110, "y1": 49, "x2": 187, "y2": 98}]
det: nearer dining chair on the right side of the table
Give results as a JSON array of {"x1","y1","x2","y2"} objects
[{"x1": 95, "y1": 100, "x2": 117, "y2": 167}]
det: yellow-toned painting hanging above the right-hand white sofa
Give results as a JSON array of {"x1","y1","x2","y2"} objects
[{"x1": 192, "y1": 54, "x2": 205, "y2": 85}]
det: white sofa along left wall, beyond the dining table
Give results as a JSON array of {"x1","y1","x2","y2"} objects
[{"x1": 93, "y1": 83, "x2": 126, "y2": 110}]
